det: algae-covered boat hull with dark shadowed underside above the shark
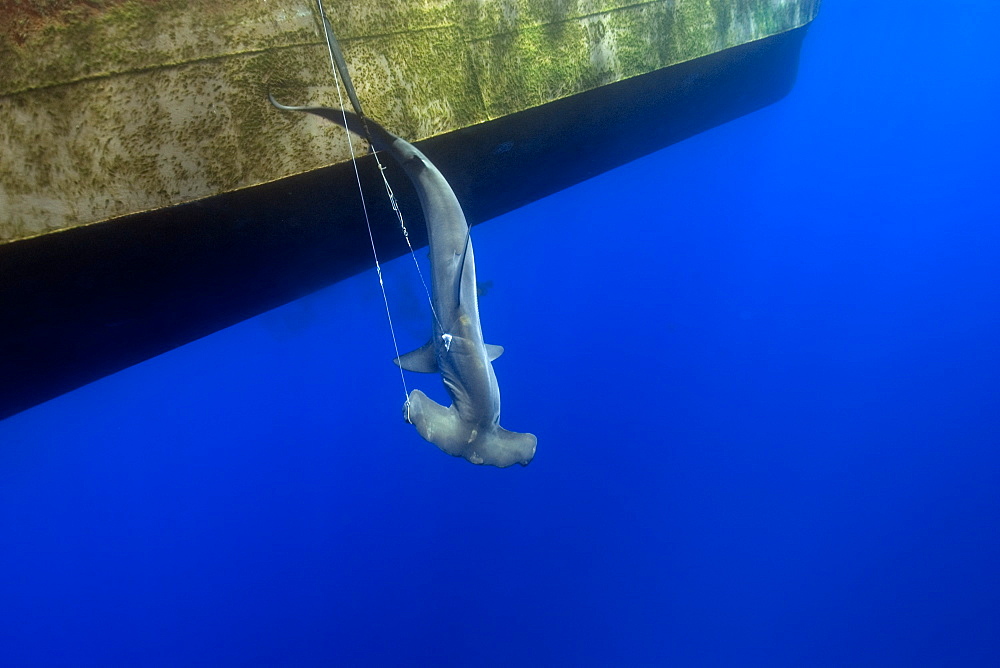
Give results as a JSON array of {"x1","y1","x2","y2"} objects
[{"x1": 0, "y1": 0, "x2": 818, "y2": 416}]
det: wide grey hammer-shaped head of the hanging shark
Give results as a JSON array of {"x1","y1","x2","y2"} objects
[{"x1": 403, "y1": 390, "x2": 538, "y2": 468}]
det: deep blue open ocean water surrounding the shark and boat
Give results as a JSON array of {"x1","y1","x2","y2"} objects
[{"x1": 0, "y1": 0, "x2": 1000, "y2": 666}]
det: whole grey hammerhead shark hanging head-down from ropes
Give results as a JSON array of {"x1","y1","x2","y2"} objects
[{"x1": 271, "y1": 96, "x2": 537, "y2": 467}]
